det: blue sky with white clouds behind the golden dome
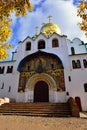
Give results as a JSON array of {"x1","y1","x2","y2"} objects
[{"x1": 9, "y1": 0, "x2": 87, "y2": 59}]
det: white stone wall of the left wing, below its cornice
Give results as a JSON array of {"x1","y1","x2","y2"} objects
[{"x1": 0, "y1": 62, "x2": 19, "y2": 98}]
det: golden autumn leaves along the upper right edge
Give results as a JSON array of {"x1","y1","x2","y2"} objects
[{"x1": 77, "y1": 1, "x2": 87, "y2": 37}]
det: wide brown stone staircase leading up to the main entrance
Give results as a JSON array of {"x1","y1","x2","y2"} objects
[{"x1": 0, "y1": 103, "x2": 71, "y2": 117}]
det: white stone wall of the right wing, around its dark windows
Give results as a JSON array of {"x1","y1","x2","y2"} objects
[{"x1": 67, "y1": 54, "x2": 87, "y2": 110}]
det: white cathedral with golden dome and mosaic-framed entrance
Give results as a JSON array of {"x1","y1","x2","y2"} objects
[{"x1": 0, "y1": 18, "x2": 87, "y2": 111}]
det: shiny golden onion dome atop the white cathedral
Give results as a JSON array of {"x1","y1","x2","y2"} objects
[{"x1": 40, "y1": 23, "x2": 61, "y2": 36}]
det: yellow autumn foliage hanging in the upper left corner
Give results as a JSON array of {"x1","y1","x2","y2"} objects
[{"x1": 0, "y1": 0, "x2": 33, "y2": 60}]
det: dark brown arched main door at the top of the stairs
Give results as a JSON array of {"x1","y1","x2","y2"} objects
[{"x1": 34, "y1": 81, "x2": 49, "y2": 102}]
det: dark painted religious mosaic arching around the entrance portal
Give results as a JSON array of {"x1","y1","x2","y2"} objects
[{"x1": 18, "y1": 52, "x2": 65, "y2": 92}]
